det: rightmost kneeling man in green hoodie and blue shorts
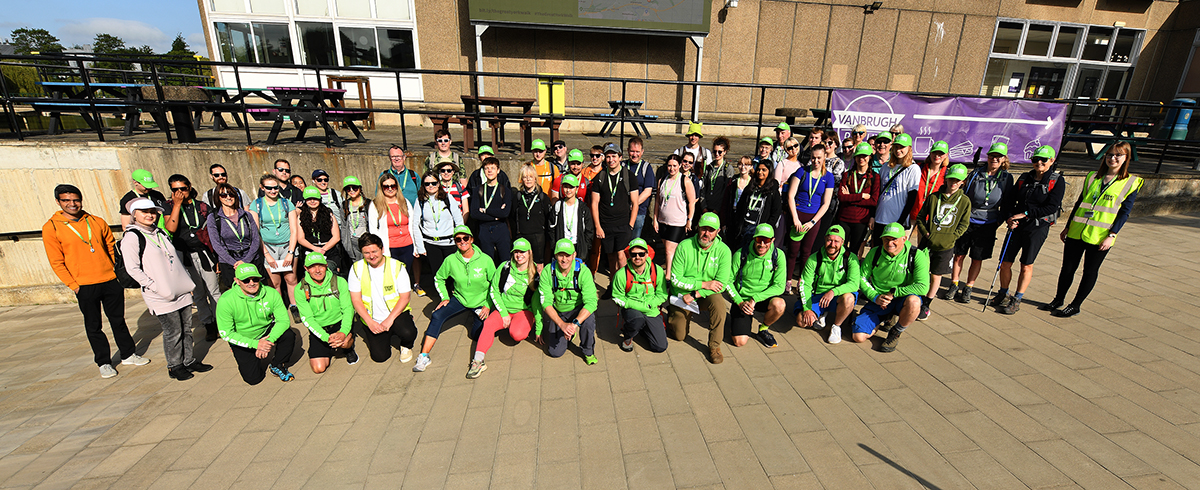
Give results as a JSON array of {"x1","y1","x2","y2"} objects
[{"x1": 853, "y1": 223, "x2": 929, "y2": 352}]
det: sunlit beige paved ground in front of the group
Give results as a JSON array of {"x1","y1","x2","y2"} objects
[{"x1": 0, "y1": 212, "x2": 1200, "y2": 489}]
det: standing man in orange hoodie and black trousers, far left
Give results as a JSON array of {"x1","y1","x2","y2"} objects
[{"x1": 42, "y1": 184, "x2": 150, "y2": 378}]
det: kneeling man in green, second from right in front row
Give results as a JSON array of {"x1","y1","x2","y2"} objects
[{"x1": 793, "y1": 225, "x2": 870, "y2": 343}]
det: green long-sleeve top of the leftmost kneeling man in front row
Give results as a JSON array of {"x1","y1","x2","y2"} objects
[{"x1": 217, "y1": 286, "x2": 290, "y2": 348}]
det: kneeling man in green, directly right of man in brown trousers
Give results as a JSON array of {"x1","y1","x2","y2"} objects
[{"x1": 730, "y1": 223, "x2": 787, "y2": 348}]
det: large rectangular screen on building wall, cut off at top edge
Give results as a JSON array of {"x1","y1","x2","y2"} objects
[{"x1": 468, "y1": 0, "x2": 712, "y2": 35}]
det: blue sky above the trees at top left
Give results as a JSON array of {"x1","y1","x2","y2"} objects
[{"x1": 0, "y1": 0, "x2": 208, "y2": 54}]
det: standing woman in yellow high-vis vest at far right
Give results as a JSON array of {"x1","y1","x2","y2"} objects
[{"x1": 1045, "y1": 142, "x2": 1142, "y2": 318}]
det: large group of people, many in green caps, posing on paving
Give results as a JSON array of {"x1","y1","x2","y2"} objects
[{"x1": 42, "y1": 123, "x2": 1142, "y2": 384}]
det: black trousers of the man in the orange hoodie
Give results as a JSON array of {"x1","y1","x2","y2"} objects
[{"x1": 76, "y1": 279, "x2": 137, "y2": 366}]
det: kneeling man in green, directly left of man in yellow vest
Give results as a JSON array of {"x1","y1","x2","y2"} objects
[{"x1": 293, "y1": 252, "x2": 359, "y2": 375}]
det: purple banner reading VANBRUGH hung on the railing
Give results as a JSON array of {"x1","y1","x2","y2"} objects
[{"x1": 830, "y1": 90, "x2": 1067, "y2": 163}]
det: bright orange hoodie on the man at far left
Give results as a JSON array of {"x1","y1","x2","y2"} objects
[{"x1": 42, "y1": 211, "x2": 116, "y2": 289}]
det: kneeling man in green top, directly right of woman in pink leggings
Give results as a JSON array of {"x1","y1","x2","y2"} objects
[{"x1": 534, "y1": 238, "x2": 598, "y2": 365}]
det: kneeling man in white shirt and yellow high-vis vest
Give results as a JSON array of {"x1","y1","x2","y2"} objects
[{"x1": 348, "y1": 233, "x2": 416, "y2": 363}]
